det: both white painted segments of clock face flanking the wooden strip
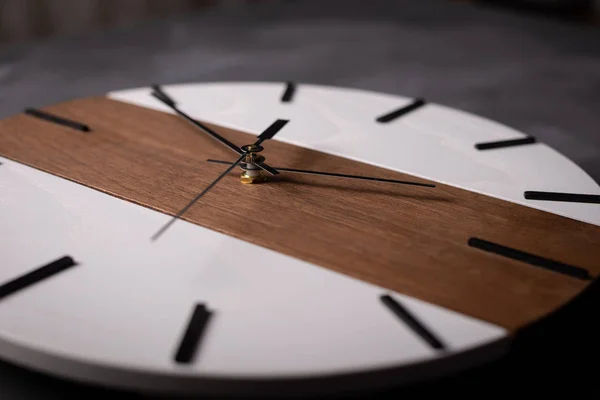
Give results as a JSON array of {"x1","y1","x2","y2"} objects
[{"x1": 0, "y1": 83, "x2": 600, "y2": 392}]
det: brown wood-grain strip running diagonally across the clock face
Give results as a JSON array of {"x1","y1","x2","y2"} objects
[{"x1": 0, "y1": 97, "x2": 600, "y2": 331}]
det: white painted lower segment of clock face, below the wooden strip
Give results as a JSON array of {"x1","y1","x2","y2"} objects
[{"x1": 0, "y1": 159, "x2": 506, "y2": 385}]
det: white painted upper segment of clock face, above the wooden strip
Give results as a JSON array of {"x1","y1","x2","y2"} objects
[{"x1": 109, "y1": 82, "x2": 600, "y2": 225}]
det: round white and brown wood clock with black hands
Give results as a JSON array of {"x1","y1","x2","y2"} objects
[{"x1": 0, "y1": 82, "x2": 600, "y2": 394}]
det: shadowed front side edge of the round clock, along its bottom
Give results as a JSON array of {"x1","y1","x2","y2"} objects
[{"x1": 0, "y1": 333, "x2": 515, "y2": 396}]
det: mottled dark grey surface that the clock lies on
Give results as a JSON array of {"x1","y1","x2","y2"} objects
[{"x1": 0, "y1": 0, "x2": 600, "y2": 400}]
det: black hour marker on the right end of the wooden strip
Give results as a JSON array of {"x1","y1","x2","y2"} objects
[{"x1": 469, "y1": 238, "x2": 592, "y2": 280}]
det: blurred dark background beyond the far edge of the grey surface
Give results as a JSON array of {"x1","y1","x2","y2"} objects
[{"x1": 0, "y1": 0, "x2": 600, "y2": 42}]
